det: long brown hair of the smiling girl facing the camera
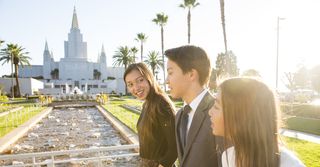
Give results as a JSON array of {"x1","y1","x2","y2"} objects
[{"x1": 123, "y1": 63, "x2": 174, "y2": 142}]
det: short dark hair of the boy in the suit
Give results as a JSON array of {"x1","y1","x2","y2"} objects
[{"x1": 164, "y1": 45, "x2": 211, "y2": 85}]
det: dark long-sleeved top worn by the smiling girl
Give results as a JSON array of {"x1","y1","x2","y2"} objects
[{"x1": 137, "y1": 100, "x2": 177, "y2": 167}]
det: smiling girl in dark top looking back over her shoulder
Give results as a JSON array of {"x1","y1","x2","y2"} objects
[{"x1": 123, "y1": 63, "x2": 177, "y2": 167}]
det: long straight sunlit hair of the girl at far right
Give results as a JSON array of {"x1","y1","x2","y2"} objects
[{"x1": 219, "y1": 78, "x2": 280, "y2": 167}]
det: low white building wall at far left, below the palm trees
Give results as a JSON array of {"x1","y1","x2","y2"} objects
[{"x1": 0, "y1": 78, "x2": 43, "y2": 96}]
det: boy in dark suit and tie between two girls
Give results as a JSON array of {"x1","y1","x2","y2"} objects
[{"x1": 165, "y1": 45, "x2": 220, "y2": 167}]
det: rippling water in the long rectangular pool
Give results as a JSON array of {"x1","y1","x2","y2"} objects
[{"x1": 0, "y1": 108, "x2": 139, "y2": 166}]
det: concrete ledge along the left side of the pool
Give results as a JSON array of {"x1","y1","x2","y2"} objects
[{"x1": 0, "y1": 107, "x2": 52, "y2": 153}]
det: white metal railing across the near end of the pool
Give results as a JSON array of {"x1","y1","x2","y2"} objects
[{"x1": 0, "y1": 144, "x2": 139, "y2": 167}]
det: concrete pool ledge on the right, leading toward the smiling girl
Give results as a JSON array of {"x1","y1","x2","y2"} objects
[{"x1": 96, "y1": 105, "x2": 139, "y2": 151}]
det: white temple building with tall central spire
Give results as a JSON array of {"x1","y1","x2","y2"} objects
[{"x1": 19, "y1": 9, "x2": 125, "y2": 94}]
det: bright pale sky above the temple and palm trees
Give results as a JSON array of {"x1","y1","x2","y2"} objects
[{"x1": 0, "y1": 0, "x2": 320, "y2": 91}]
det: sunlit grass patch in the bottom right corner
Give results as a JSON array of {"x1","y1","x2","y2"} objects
[{"x1": 282, "y1": 137, "x2": 320, "y2": 167}]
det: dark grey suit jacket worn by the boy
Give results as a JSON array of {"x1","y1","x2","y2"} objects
[{"x1": 175, "y1": 92, "x2": 220, "y2": 167}]
